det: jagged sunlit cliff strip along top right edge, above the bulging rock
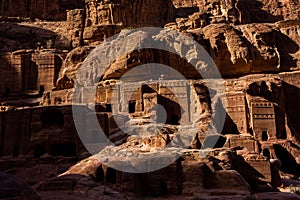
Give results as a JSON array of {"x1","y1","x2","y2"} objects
[{"x1": 173, "y1": 0, "x2": 300, "y2": 28}]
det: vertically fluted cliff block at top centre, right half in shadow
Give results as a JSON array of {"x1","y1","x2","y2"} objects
[{"x1": 86, "y1": 0, "x2": 174, "y2": 28}]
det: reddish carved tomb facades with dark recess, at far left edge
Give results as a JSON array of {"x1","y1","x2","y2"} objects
[{"x1": 0, "y1": 51, "x2": 62, "y2": 96}]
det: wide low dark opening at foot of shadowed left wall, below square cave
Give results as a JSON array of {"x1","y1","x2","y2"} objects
[{"x1": 49, "y1": 143, "x2": 76, "y2": 157}]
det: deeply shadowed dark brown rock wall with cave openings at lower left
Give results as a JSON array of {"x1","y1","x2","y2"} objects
[{"x1": 0, "y1": 106, "x2": 85, "y2": 157}]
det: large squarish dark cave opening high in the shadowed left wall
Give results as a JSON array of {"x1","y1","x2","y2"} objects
[{"x1": 40, "y1": 109, "x2": 65, "y2": 129}]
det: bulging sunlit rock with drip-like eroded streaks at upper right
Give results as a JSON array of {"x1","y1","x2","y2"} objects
[{"x1": 199, "y1": 21, "x2": 299, "y2": 76}]
